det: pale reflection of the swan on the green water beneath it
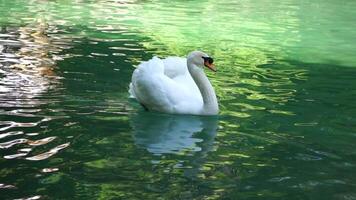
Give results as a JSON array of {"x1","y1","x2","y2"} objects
[{"x1": 131, "y1": 112, "x2": 218, "y2": 158}]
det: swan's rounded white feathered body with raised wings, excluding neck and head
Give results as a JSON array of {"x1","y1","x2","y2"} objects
[{"x1": 129, "y1": 57, "x2": 203, "y2": 114}]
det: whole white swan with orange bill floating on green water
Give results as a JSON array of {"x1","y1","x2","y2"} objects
[{"x1": 129, "y1": 51, "x2": 219, "y2": 115}]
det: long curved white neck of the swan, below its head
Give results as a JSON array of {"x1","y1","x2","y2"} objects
[{"x1": 187, "y1": 60, "x2": 219, "y2": 115}]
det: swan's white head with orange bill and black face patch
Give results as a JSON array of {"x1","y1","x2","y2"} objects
[{"x1": 187, "y1": 51, "x2": 216, "y2": 72}]
